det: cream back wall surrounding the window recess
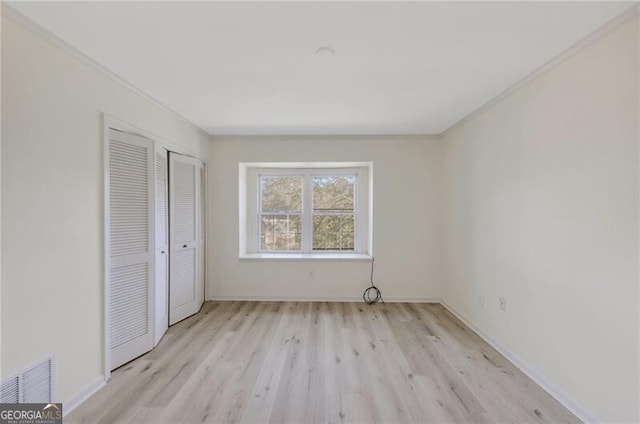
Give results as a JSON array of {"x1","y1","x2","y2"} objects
[{"x1": 207, "y1": 137, "x2": 442, "y2": 300}]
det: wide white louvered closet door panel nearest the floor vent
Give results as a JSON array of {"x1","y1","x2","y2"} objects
[{"x1": 108, "y1": 130, "x2": 155, "y2": 369}]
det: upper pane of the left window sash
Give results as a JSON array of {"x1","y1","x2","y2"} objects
[{"x1": 260, "y1": 176, "x2": 302, "y2": 212}]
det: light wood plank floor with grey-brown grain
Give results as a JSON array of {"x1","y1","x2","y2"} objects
[{"x1": 65, "y1": 302, "x2": 580, "y2": 424}]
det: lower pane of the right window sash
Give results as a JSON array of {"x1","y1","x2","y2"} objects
[{"x1": 313, "y1": 214, "x2": 354, "y2": 250}]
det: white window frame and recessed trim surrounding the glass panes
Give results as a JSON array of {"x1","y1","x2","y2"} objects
[{"x1": 238, "y1": 162, "x2": 373, "y2": 260}]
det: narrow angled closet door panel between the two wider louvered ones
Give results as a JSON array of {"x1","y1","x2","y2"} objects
[{"x1": 154, "y1": 148, "x2": 169, "y2": 345}]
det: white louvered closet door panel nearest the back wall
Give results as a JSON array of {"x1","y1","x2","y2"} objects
[{"x1": 169, "y1": 152, "x2": 204, "y2": 325}]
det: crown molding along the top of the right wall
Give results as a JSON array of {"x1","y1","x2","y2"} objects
[{"x1": 440, "y1": 2, "x2": 640, "y2": 138}]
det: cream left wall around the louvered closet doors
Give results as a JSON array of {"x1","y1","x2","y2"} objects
[{"x1": 1, "y1": 10, "x2": 206, "y2": 401}]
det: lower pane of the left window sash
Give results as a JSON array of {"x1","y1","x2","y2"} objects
[{"x1": 260, "y1": 215, "x2": 302, "y2": 251}]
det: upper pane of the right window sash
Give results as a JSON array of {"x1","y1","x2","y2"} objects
[{"x1": 313, "y1": 175, "x2": 356, "y2": 212}]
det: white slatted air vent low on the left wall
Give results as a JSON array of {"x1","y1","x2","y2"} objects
[{"x1": 0, "y1": 355, "x2": 54, "y2": 403}]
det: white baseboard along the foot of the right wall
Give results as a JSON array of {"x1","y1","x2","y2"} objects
[{"x1": 440, "y1": 301, "x2": 601, "y2": 424}]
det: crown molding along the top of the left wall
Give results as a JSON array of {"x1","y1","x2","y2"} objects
[{"x1": 0, "y1": 2, "x2": 212, "y2": 139}]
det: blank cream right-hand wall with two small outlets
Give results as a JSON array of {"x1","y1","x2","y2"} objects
[{"x1": 444, "y1": 12, "x2": 640, "y2": 422}]
